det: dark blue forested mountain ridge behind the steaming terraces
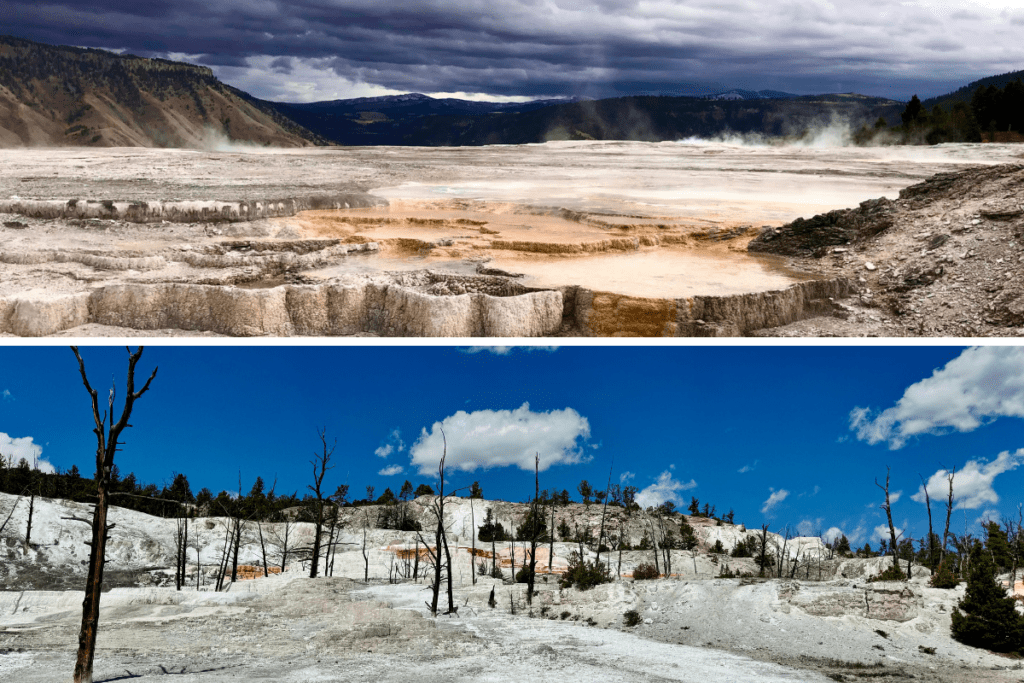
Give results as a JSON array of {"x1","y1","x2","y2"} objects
[{"x1": 274, "y1": 93, "x2": 903, "y2": 146}]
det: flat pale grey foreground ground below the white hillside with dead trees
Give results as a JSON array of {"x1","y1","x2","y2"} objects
[{"x1": 0, "y1": 575, "x2": 1024, "y2": 683}]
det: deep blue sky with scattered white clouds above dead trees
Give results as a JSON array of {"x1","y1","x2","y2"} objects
[{"x1": 0, "y1": 346, "x2": 1024, "y2": 546}]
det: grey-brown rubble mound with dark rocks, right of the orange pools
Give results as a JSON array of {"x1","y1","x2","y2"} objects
[{"x1": 750, "y1": 164, "x2": 1024, "y2": 337}]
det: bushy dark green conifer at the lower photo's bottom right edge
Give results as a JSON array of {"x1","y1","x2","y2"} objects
[{"x1": 951, "y1": 543, "x2": 1024, "y2": 653}]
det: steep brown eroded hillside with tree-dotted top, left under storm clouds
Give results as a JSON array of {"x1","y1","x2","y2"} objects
[{"x1": 0, "y1": 36, "x2": 322, "y2": 147}]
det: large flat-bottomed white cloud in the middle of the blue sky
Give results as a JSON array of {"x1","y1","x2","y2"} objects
[{"x1": 410, "y1": 403, "x2": 590, "y2": 474}]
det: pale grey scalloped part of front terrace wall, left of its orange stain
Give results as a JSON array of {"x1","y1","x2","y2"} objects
[{"x1": 0, "y1": 283, "x2": 563, "y2": 337}]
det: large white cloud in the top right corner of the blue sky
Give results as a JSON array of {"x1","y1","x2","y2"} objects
[{"x1": 850, "y1": 346, "x2": 1024, "y2": 450}]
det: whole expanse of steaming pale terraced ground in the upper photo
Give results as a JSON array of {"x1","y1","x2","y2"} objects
[{"x1": 0, "y1": 142, "x2": 1020, "y2": 337}]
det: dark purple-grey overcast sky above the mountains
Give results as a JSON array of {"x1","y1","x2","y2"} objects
[{"x1": 0, "y1": 0, "x2": 1024, "y2": 101}]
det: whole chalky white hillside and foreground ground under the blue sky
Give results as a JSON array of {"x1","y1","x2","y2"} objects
[{"x1": 0, "y1": 496, "x2": 1024, "y2": 683}]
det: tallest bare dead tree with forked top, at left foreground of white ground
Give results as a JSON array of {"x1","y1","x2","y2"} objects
[{"x1": 72, "y1": 346, "x2": 157, "y2": 683}]
